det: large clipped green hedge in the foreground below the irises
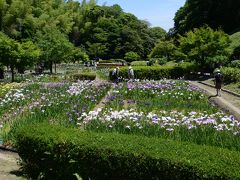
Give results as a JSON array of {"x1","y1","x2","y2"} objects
[{"x1": 15, "y1": 124, "x2": 240, "y2": 179}]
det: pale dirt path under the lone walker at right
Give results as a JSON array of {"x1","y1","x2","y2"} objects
[{"x1": 190, "y1": 81, "x2": 240, "y2": 121}]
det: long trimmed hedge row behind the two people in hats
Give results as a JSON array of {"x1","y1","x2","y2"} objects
[{"x1": 109, "y1": 63, "x2": 196, "y2": 80}]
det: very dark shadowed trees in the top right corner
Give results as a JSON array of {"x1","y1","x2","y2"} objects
[{"x1": 172, "y1": 0, "x2": 240, "y2": 35}]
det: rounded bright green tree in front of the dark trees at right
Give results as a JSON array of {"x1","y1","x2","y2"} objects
[{"x1": 177, "y1": 27, "x2": 230, "y2": 70}]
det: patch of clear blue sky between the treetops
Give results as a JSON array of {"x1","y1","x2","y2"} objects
[{"x1": 95, "y1": 0, "x2": 186, "y2": 31}]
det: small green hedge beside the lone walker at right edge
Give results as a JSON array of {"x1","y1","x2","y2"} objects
[{"x1": 221, "y1": 67, "x2": 240, "y2": 83}]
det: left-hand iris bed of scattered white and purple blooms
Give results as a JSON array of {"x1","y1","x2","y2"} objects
[{"x1": 0, "y1": 81, "x2": 110, "y2": 142}]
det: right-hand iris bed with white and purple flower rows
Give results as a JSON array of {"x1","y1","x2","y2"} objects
[{"x1": 74, "y1": 80, "x2": 240, "y2": 150}]
